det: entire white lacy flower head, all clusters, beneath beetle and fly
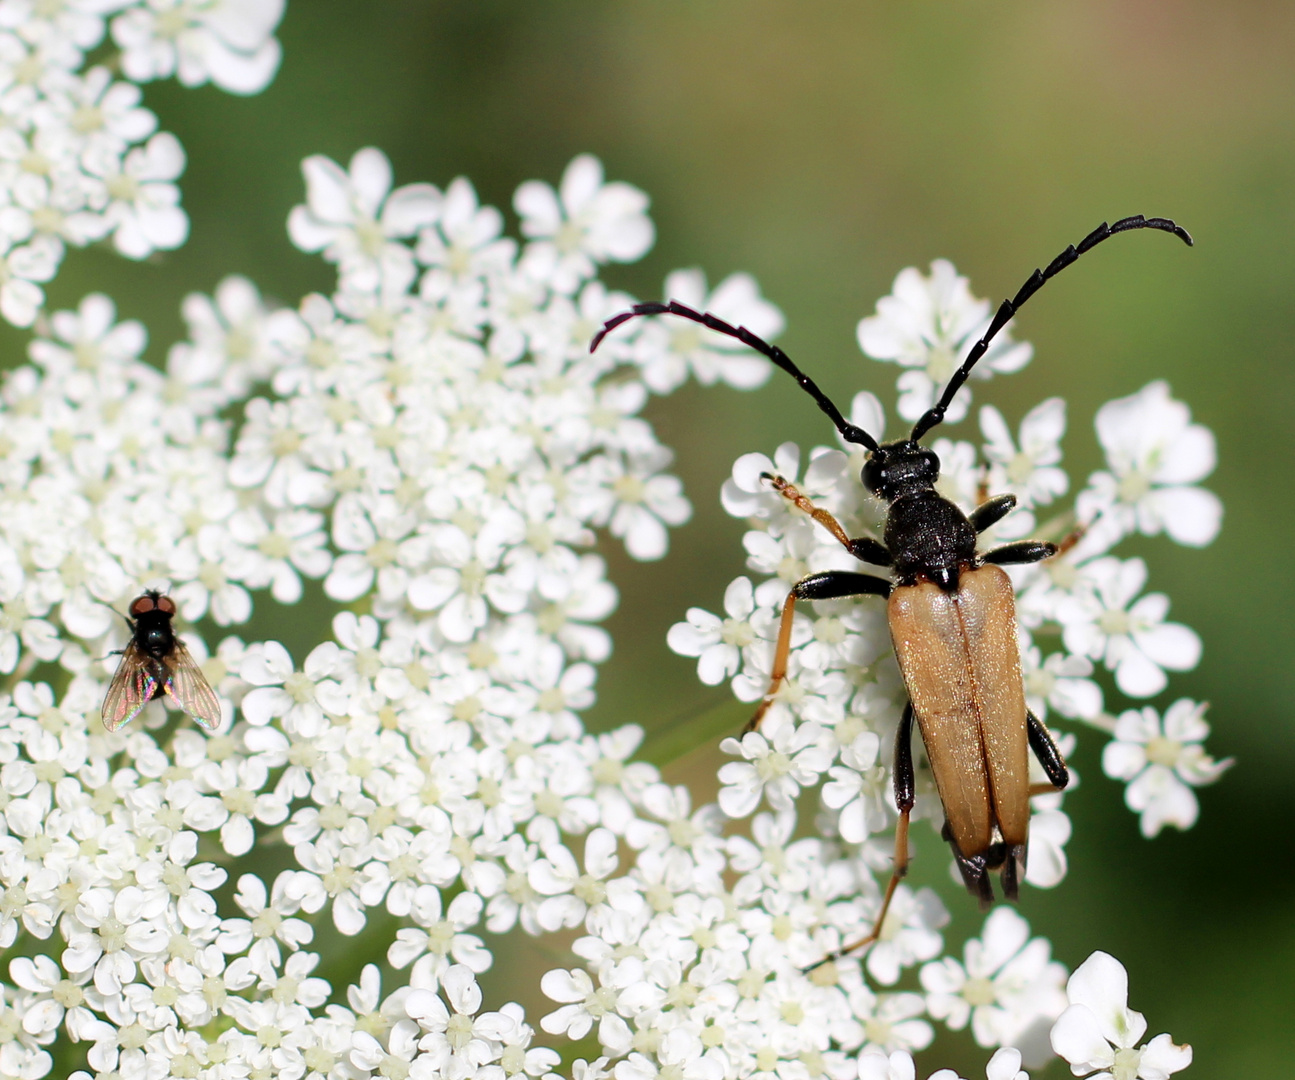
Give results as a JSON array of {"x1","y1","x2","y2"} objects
[{"x1": 0, "y1": 8, "x2": 1206, "y2": 1080}]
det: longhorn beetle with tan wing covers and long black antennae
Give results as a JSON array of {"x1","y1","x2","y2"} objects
[{"x1": 589, "y1": 215, "x2": 1191, "y2": 966}]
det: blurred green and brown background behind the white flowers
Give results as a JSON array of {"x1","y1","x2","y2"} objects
[{"x1": 22, "y1": 0, "x2": 1295, "y2": 1077}]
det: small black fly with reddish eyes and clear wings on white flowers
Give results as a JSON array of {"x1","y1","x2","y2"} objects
[{"x1": 104, "y1": 589, "x2": 220, "y2": 732}]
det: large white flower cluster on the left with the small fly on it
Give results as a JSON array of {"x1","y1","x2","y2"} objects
[{"x1": 0, "y1": 143, "x2": 963, "y2": 1076}]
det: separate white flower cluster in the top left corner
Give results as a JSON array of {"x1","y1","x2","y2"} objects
[{"x1": 0, "y1": 0, "x2": 284, "y2": 326}]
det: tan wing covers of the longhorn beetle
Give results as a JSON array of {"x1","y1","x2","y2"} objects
[{"x1": 887, "y1": 565, "x2": 1030, "y2": 856}]
